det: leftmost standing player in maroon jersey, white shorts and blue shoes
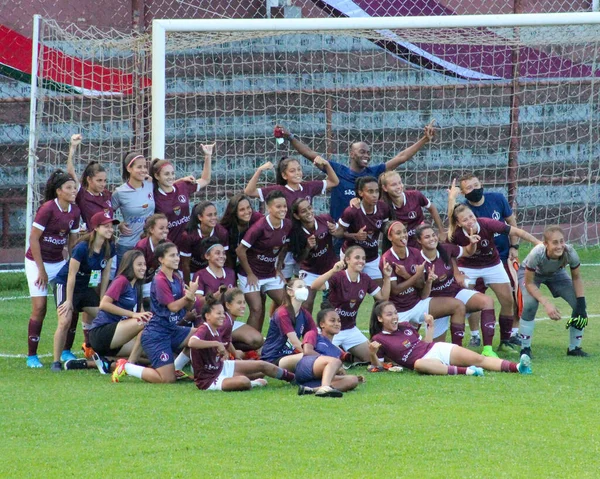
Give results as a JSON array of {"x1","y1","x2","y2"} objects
[{"x1": 25, "y1": 170, "x2": 80, "y2": 368}]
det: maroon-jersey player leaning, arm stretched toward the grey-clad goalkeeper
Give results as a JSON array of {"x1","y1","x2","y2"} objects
[{"x1": 448, "y1": 205, "x2": 541, "y2": 351}]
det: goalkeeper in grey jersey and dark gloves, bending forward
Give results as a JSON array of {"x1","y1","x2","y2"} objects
[{"x1": 519, "y1": 226, "x2": 588, "y2": 357}]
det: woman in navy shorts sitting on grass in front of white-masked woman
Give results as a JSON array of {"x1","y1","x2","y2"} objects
[{"x1": 296, "y1": 308, "x2": 364, "y2": 397}]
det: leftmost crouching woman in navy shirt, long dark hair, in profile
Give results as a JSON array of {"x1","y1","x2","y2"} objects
[{"x1": 90, "y1": 249, "x2": 152, "y2": 374}]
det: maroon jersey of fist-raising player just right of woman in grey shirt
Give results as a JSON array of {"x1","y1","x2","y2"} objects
[{"x1": 154, "y1": 180, "x2": 200, "y2": 250}]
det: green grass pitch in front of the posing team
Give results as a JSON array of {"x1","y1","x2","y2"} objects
[{"x1": 0, "y1": 250, "x2": 600, "y2": 479}]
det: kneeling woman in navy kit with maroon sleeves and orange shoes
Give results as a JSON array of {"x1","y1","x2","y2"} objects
[{"x1": 112, "y1": 243, "x2": 198, "y2": 383}]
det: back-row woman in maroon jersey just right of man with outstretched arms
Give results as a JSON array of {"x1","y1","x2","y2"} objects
[{"x1": 379, "y1": 171, "x2": 446, "y2": 251}]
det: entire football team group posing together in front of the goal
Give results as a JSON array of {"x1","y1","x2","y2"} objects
[{"x1": 25, "y1": 122, "x2": 588, "y2": 397}]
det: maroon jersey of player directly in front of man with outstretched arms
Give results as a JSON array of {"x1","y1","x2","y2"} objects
[{"x1": 338, "y1": 201, "x2": 390, "y2": 263}]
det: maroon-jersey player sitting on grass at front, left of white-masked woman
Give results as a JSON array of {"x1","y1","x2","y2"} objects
[{"x1": 188, "y1": 296, "x2": 294, "y2": 391}]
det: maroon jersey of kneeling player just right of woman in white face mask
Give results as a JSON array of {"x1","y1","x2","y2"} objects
[{"x1": 327, "y1": 270, "x2": 381, "y2": 329}]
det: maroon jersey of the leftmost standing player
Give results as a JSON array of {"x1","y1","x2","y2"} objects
[{"x1": 25, "y1": 199, "x2": 80, "y2": 263}]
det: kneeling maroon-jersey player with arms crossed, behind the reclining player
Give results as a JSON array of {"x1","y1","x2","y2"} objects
[{"x1": 381, "y1": 221, "x2": 466, "y2": 346}]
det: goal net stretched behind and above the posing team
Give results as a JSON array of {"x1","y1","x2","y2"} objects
[{"x1": 34, "y1": 14, "x2": 600, "y2": 244}]
